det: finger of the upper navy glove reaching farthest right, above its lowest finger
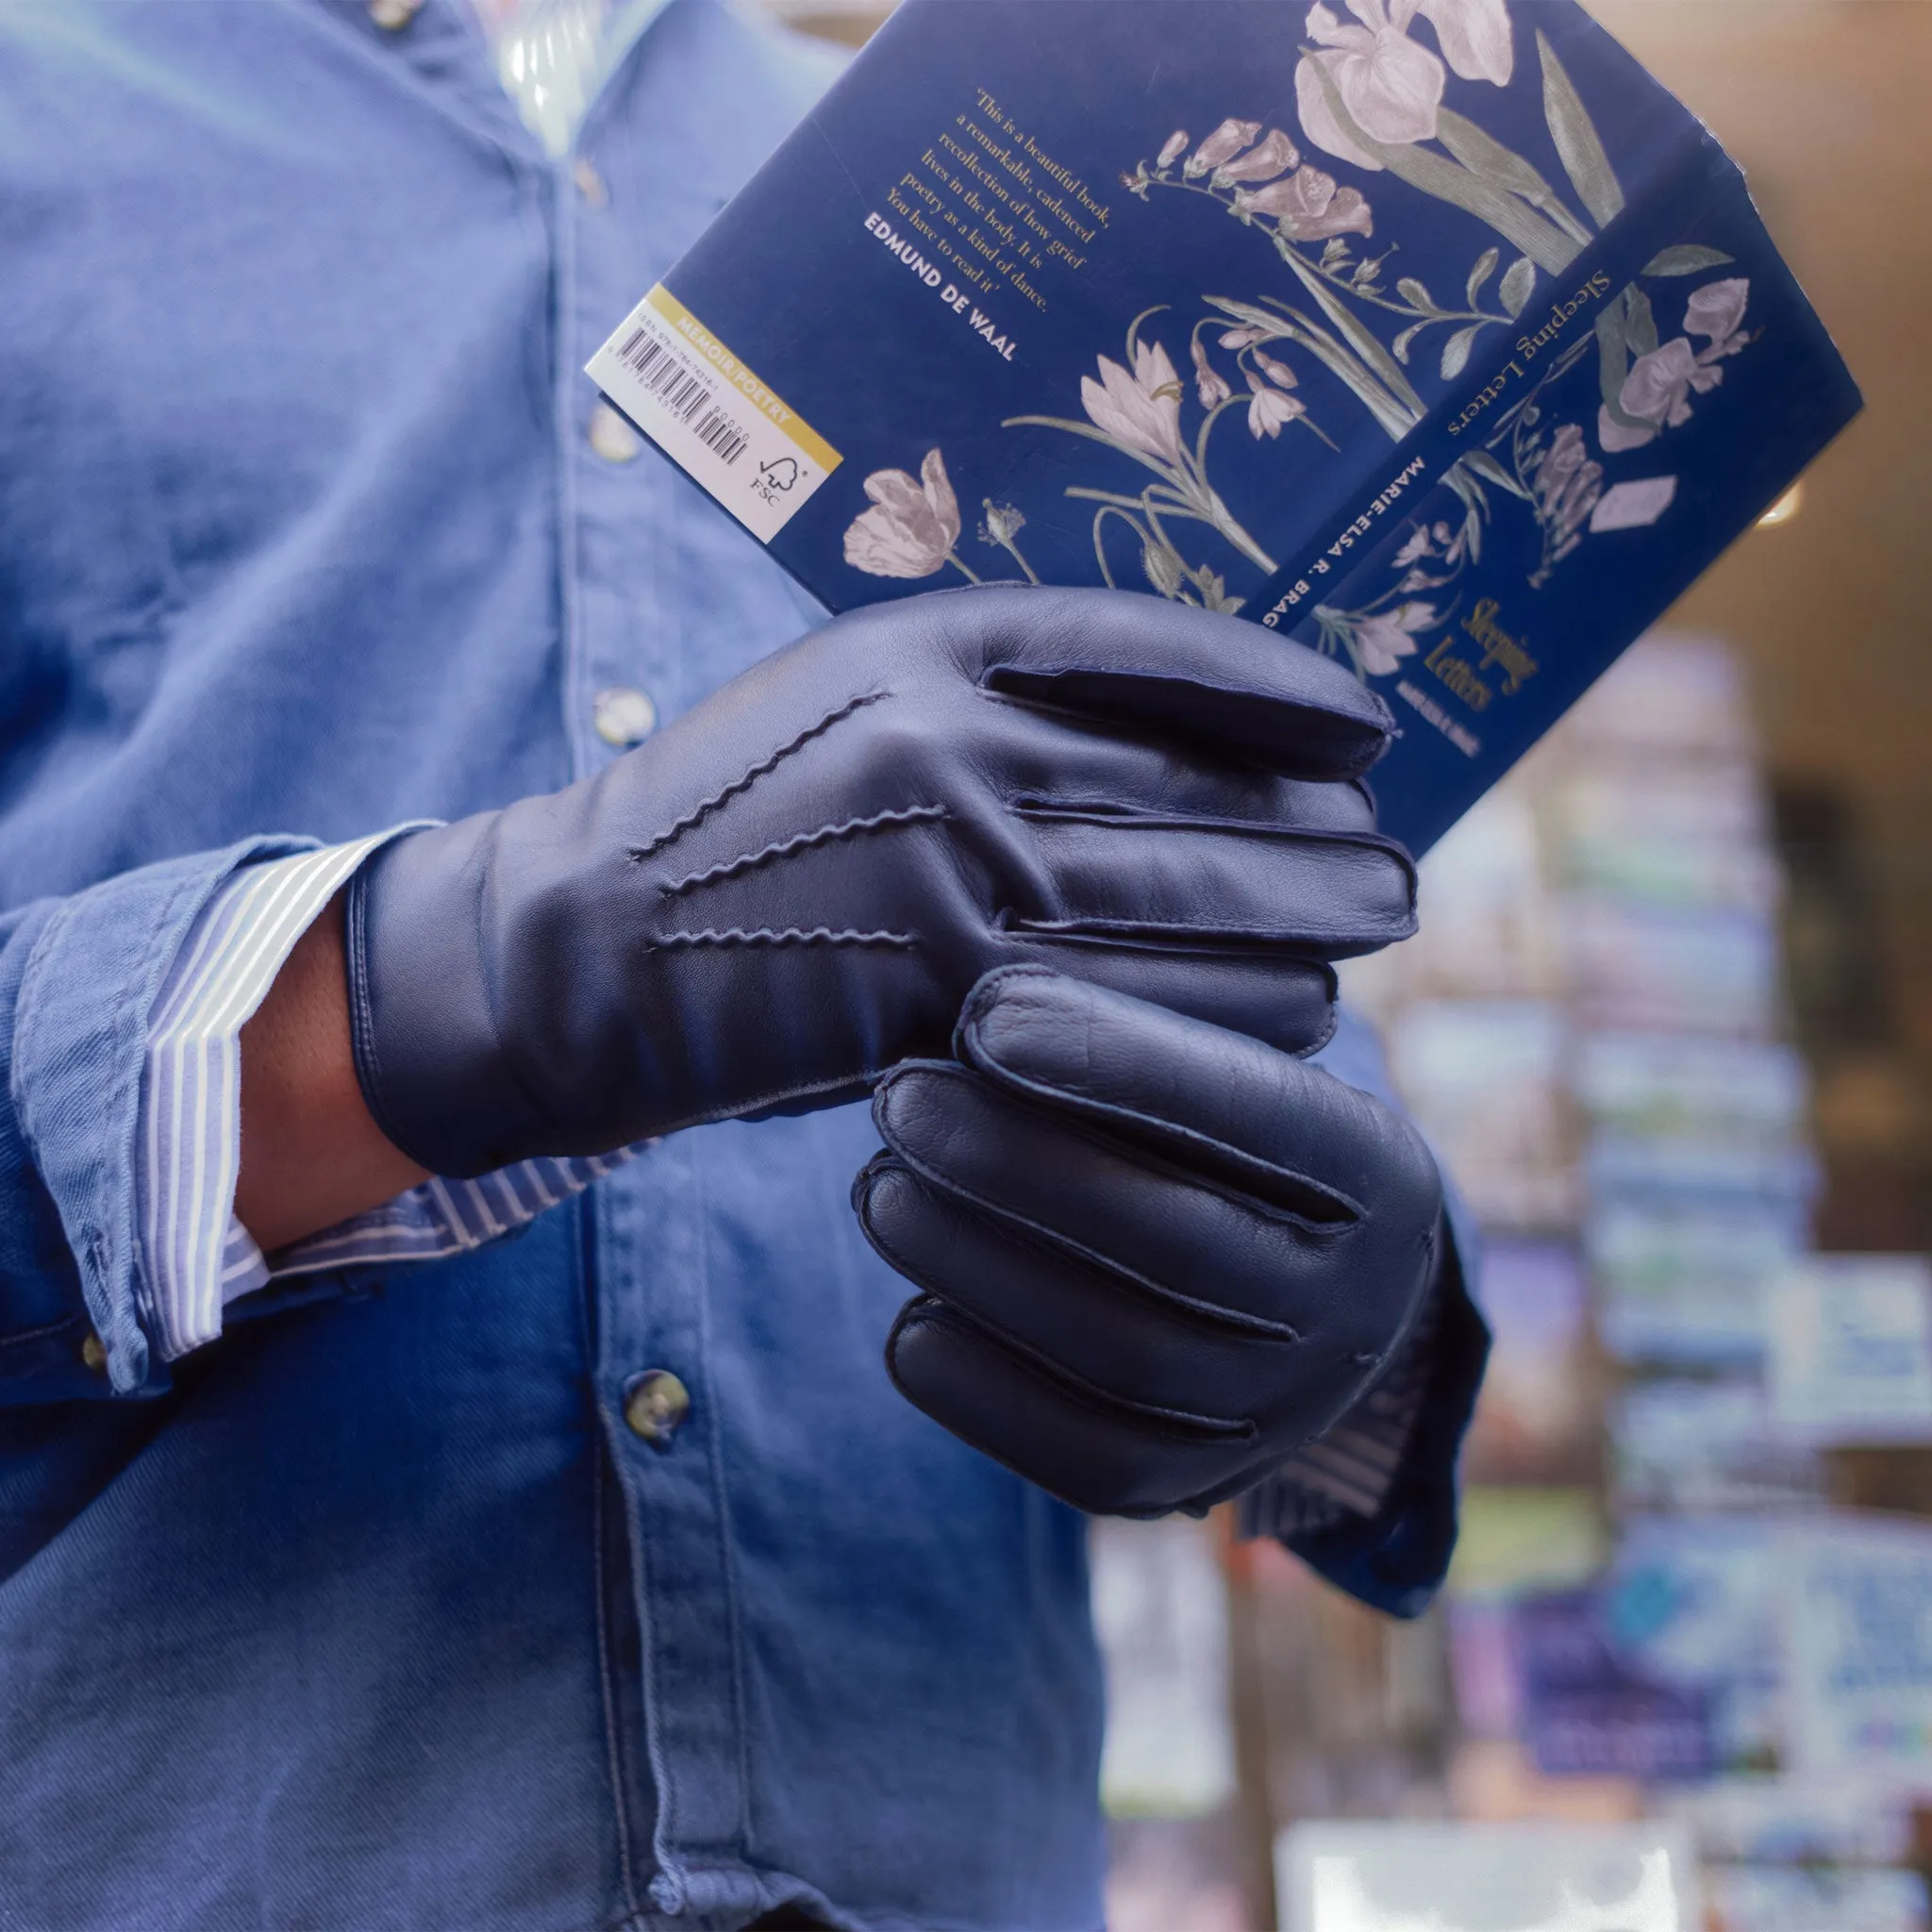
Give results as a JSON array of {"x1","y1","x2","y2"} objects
[{"x1": 1003, "y1": 806, "x2": 1416, "y2": 958}]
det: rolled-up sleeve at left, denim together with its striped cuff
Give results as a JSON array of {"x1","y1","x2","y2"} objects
[{"x1": 0, "y1": 824, "x2": 649, "y2": 1403}]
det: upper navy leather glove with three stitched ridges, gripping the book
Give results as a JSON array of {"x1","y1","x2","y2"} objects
[{"x1": 348, "y1": 588, "x2": 1414, "y2": 1174}]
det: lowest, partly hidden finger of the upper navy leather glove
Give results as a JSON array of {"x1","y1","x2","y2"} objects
[{"x1": 1003, "y1": 933, "x2": 1335, "y2": 1053}]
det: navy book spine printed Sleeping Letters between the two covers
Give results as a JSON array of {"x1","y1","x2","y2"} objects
[{"x1": 1242, "y1": 129, "x2": 1744, "y2": 630}]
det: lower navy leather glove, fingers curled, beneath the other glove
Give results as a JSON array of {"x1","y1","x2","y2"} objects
[{"x1": 852, "y1": 966, "x2": 1445, "y2": 1517}]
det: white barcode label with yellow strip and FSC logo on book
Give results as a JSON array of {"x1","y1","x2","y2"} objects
[{"x1": 590, "y1": 284, "x2": 839, "y2": 542}]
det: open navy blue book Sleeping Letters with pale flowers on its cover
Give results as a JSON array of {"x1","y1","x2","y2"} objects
[{"x1": 590, "y1": 0, "x2": 1858, "y2": 852}]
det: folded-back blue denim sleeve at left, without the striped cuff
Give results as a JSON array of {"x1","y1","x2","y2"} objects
[{"x1": 0, "y1": 839, "x2": 308, "y2": 1403}]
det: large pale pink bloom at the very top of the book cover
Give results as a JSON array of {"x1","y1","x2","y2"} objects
[{"x1": 1294, "y1": 0, "x2": 1515, "y2": 168}]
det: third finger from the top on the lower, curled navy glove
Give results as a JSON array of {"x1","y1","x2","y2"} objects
[{"x1": 852, "y1": 1154, "x2": 1377, "y2": 1447}]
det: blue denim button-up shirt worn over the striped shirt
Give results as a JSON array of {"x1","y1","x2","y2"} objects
[{"x1": 0, "y1": 0, "x2": 1480, "y2": 1932}]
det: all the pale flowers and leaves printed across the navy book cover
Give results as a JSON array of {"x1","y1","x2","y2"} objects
[{"x1": 844, "y1": 0, "x2": 1755, "y2": 678}]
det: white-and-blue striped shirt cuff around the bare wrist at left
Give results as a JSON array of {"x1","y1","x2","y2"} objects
[{"x1": 139, "y1": 833, "x2": 630, "y2": 1360}]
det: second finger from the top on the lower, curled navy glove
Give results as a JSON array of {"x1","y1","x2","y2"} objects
[{"x1": 874, "y1": 1060, "x2": 1424, "y2": 1364}]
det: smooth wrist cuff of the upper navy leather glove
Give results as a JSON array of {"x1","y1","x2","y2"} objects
[{"x1": 344, "y1": 813, "x2": 557, "y2": 1178}]
